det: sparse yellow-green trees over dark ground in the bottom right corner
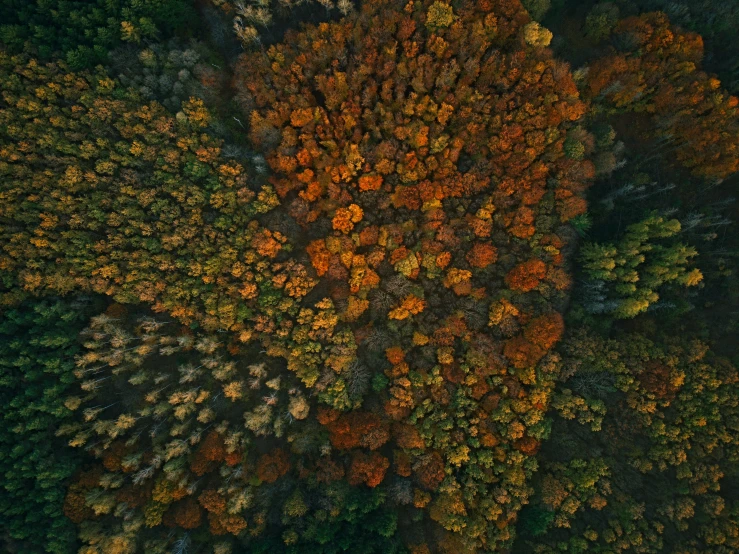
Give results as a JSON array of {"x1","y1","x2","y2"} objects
[{"x1": 514, "y1": 328, "x2": 739, "y2": 552}]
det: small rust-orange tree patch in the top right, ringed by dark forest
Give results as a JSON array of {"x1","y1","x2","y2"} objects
[{"x1": 585, "y1": 12, "x2": 739, "y2": 179}]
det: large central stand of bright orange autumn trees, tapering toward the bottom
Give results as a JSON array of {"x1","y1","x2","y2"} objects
[{"x1": 234, "y1": 0, "x2": 595, "y2": 550}]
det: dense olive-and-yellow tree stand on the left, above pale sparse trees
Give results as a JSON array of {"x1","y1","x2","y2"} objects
[{"x1": 0, "y1": 54, "x2": 314, "y2": 332}]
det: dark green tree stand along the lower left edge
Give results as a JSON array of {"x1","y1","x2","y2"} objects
[{"x1": 0, "y1": 298, "x2": 95, "y2": 553}]
